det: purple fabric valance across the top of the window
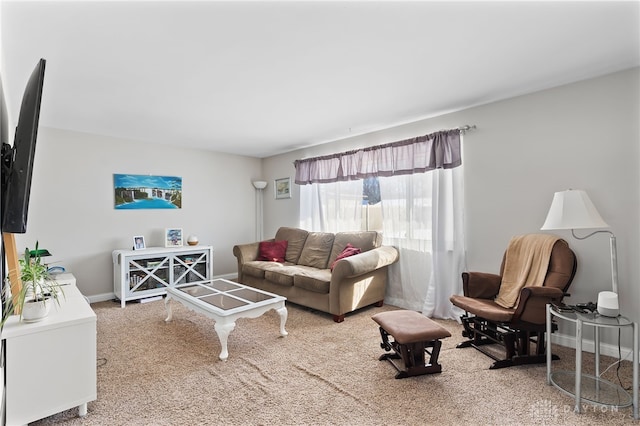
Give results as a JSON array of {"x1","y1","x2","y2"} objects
[{"x1": 294, "y1": 129, "x2": 462, "y2": 185}]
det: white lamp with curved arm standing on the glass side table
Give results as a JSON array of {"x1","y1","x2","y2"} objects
[{"x1": 541, "y1": 189, "x2": 619, "y2": 317}]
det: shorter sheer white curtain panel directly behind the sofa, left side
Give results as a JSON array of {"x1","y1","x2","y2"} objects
[{"x1": 300, "y1": 180, "x2": 362, "y2": 232}]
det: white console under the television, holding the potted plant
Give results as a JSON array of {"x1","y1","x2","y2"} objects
[{"x1": 1, "y1": 274, "x2": 97, "y2": 426}]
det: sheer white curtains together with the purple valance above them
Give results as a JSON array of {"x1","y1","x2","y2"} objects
[{"x1": 295, "y1": 129, "x2": 465, "y2": 318}]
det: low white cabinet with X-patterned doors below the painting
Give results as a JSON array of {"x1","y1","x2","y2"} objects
[{"x1": 113, "y1": 246, "x2": 213, "y2": 308}]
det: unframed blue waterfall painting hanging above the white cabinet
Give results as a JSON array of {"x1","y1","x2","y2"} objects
[{"x1": 113, "y1": 174, "x2": 182, "y2": 210}]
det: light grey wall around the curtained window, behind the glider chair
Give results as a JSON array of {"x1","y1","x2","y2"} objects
[{"x1": 263, "y1": 68, "x2": 640, "y2": 346}]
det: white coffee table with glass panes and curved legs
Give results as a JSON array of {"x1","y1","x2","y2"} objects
[{"x1": 164, "y1": 279, "x2": 289, "y2": 361}]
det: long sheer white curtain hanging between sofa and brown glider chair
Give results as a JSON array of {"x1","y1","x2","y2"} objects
[{"x1": 379, "y1": 167, "x2": 465, "y2": 319}]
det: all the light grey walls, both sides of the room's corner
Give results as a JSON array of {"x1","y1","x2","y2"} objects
[{"x1": 6, "y1": 68, "x2": 640, "y2": 352}]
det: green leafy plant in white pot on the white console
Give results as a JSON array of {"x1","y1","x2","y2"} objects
[{"x1": 13, "y1": 241, "x2": 60, "y2": 322}]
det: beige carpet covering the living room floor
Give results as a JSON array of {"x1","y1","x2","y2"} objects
[{"x1": 35, "y1": 301, "x2": 637, "y2": 425}]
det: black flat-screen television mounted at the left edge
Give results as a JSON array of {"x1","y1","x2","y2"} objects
[{"x1": 1, "y1": 59, "x2": 46, "y2": 234}]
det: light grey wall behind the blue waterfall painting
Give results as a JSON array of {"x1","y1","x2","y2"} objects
[{"x1": 16, "y1": 128, "x2": 261, "y2": 300}]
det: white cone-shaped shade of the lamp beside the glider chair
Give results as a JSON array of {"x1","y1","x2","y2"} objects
[{"x1": 540, "y1": 189, "x2": 609, "y2": 230}]
